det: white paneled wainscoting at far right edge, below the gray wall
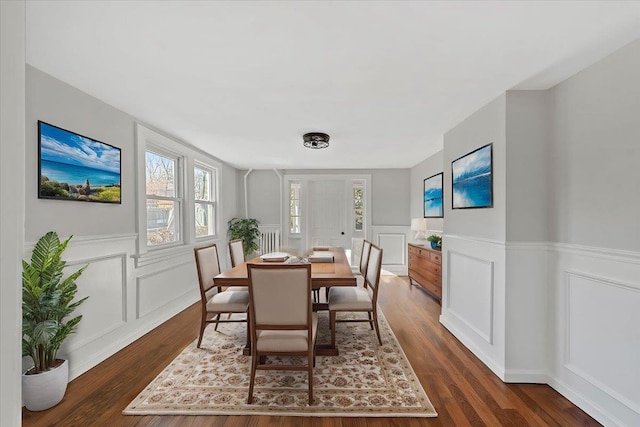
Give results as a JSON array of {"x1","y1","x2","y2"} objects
[{"x1": 548, "y1": 244, "x2": 640, "y2": 426}]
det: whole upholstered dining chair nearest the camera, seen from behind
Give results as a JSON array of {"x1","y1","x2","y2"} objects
[{"x1": 247, "y1": 264, "x2": 318, "y2": 404}]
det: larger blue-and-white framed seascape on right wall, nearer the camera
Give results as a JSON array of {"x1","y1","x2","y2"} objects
[{"x1": 451, "y1": 144, "x2": 493, "y2": 209}]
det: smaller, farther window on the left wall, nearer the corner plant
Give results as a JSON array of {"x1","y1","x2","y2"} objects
[{"x1": 193, "y1": 166, "x2": 216, "y2": 237}]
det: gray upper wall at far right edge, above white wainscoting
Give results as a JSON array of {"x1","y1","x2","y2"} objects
[{"x1": 549, "y1": 40, "x2": 640, "y2": 251}]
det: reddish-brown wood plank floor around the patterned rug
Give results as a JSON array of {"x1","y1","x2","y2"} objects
[{"x1": 22, "y1": 276, "x2": 600, "y2": 427}]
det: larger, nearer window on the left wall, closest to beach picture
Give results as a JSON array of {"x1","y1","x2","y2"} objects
[{"x1": 145, "y1": 150, "x2": 182, "y2": 247}]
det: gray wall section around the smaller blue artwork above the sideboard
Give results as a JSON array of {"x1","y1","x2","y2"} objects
[{"x1": 411, "y1": 150, "x2": 444, "y2": 231}]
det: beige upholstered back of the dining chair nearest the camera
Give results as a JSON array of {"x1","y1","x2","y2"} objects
[{"x1": 247, "y1": 264, "x2": 312, "y2": 331}]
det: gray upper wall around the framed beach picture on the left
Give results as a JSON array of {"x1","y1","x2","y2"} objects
[{"x1": 25, "y1": 65, "x2": 136, "y2": 241}]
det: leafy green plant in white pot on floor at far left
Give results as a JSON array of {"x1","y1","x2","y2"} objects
[{"x1": 22, "y1": 231, "x2": 87, "y2": 411}]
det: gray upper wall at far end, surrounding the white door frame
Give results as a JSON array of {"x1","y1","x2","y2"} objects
[{"x1": 237, "y1": 169, "x2": 411, "y2": 225}]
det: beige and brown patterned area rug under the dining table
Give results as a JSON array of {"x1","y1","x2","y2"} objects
[{"x1": 123, "y1": 312, "x2": 437, "y2": 417}]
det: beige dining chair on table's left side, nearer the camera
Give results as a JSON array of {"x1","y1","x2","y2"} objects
[{"x1": 194, "y1": 243, "x2": 249, "y2": 348}]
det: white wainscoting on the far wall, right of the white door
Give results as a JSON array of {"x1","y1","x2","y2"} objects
[{"x1": 371, "y1": 225, "x2": 411, "y2": 276}]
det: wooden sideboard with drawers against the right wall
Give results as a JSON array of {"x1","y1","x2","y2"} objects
[{"x1": 409, "y1": 243, "x2": 442, "y2": 301}]
